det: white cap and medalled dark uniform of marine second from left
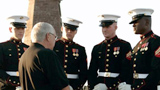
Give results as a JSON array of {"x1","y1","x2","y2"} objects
[{"x1": 54, "y1": 18, "x2": 87, "y2": 90}]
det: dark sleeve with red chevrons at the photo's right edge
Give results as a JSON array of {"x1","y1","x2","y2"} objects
[{"x1": 142, "y1": 38, "x2": 160, "y2": 90}]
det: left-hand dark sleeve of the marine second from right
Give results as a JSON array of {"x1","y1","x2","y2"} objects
[{"x1": 88, "y1": 47, "x2": 98, "y2": 90}]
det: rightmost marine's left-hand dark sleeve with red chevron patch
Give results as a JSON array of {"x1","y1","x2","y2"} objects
[{"x1": 120, "y1": 43, "x2": 132, "y2": 83}]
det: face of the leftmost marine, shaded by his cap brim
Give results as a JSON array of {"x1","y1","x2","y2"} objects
[{"x1": 9, "y1": 27, "x2": 25, "y2": 40}]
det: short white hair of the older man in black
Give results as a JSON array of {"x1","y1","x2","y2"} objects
[{"x1": 31, "y1": 22, "x2": 56, "y2": 42}]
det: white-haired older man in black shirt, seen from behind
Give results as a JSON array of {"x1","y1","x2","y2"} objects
[{"x1": 19, "y1": 22, "x2": 70, "y2": 90}]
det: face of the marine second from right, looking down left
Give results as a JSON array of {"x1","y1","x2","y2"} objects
[{"x1": 102, "y1": 23, "x2": 117, "y2": 40}]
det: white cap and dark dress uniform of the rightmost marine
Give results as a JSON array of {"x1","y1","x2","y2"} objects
[{"x1": 129, "y1": 9, "x2": 160, "y2": 90}]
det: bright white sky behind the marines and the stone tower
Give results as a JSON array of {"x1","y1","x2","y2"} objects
[{"x1": 0, "y1": 0, "x2": 160, "y2": 60}]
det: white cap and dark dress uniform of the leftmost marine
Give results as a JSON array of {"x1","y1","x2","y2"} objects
[{"x1": 0, "y1": 16, "x2": 28, "y2": 90}]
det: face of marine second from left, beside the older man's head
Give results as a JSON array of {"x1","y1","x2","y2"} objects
[{"x1": 62, "y1": 27, "x2": 77, "y2": 40}]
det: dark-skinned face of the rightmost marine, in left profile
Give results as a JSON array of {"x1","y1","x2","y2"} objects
[{"x1": 133, "y1": 18, "x2": 145, "y2": 34}]
